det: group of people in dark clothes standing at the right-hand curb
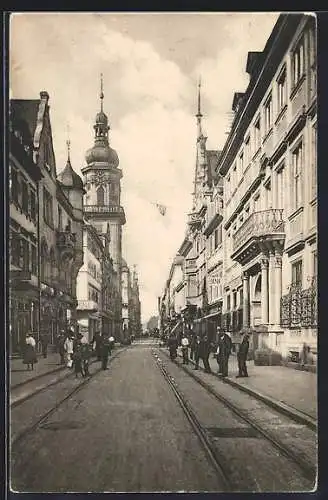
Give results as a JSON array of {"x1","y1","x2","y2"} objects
[{"x1": 167, "y1": 332, "x2": 249, "y2": 378}]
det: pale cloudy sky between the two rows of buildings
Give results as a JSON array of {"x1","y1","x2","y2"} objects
[{"x1": 10, "y1": 13, "x2": 278, "y2": 321}]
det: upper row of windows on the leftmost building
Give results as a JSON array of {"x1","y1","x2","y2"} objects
[{"x1": 9, "y1": 165, "x2": 37, "y2": 222}]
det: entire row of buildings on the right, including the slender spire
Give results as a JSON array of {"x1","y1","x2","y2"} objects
[{"x1": 159, "y1": 14, "x2": 317, "y2": 359}]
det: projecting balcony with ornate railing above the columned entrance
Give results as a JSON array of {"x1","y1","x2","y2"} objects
[{"x1": 231, "y1": 208, "x2": 285, "y2": 263}]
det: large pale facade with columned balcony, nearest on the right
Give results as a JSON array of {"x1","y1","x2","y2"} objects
[{"x1": 218, "y1": 14, "x2": 317, "y2": 358}]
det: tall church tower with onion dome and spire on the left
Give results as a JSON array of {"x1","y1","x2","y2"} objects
[{"x1": 81, "y1": 78, "x2": 125, "y2": 336}]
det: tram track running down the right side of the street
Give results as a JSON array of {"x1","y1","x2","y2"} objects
[{"x1": 152, "y1": 348, "x2": 317, "y2": 491}]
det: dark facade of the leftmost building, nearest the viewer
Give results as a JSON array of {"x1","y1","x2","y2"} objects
[{"x1": 9, "y1": 102, "x2": 41, "y2": 354}]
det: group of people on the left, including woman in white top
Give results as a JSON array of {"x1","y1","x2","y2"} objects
[{"x1": 23, "y1": 329, "x2": 115, "y2": 377}]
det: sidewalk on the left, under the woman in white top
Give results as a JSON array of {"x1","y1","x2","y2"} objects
[{"x1": 9, "y1": 353, "x2": 65, "y2": 388}]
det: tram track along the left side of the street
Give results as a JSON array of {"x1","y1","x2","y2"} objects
[{"x1": 10, "y1": 347, "x2": 127, "y2": 449}]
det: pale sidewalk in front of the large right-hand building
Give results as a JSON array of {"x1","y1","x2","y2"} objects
[{"x1": 204, "y1": 354, "x2": 317, "y2": 419}]
